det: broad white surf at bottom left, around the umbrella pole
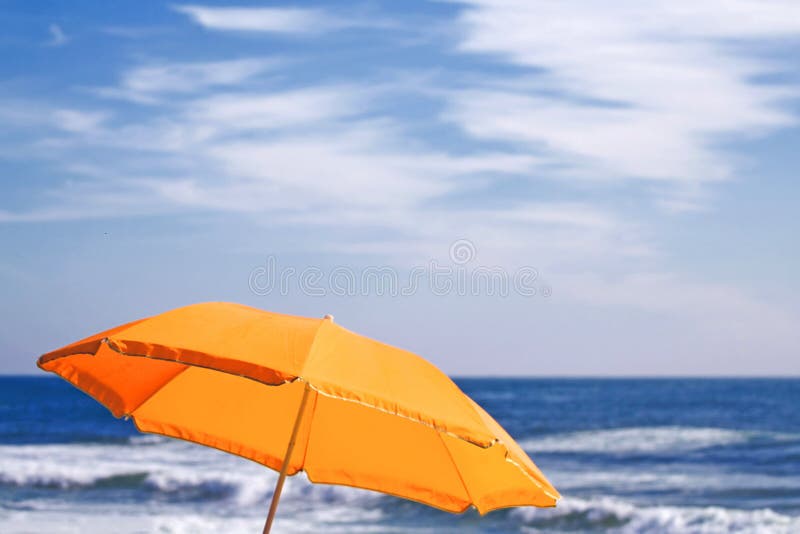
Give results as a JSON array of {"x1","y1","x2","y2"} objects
[{"x1": 0, "y1": 439, "x2": 396, "y2": 534}]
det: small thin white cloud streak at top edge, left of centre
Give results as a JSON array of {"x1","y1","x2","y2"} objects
[{"x1": 175, "y1": 5, "x2": 346, "y2": 34}]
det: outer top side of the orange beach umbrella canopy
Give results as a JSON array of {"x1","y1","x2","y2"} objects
[{"x1": 40, "y1": 303, "x2": 504, "y2": 447}]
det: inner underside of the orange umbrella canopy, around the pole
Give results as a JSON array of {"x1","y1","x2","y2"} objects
[{"x1": 37, "y1": 346, "x2": 554, "y2": 512}]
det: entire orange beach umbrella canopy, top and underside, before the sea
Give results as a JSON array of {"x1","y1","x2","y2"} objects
[{"x1": 38, "y1": 303, "x2": 559, "y2": 532}]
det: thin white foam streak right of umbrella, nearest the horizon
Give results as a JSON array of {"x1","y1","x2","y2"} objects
[{"x1": 519, "y1": 426, "x2": 757, "y2": 454}]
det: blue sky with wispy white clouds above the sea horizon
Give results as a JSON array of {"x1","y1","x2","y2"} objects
[{"x1": 0, "y1": 0, "x2": 800, "y2": 376}]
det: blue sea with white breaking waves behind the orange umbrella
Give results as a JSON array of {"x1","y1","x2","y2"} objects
[{"x1": 0, "y1": 377, "x2": 800, "y2": 533}]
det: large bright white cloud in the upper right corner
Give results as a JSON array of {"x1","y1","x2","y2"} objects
[{"x1": 446, "y1": 0, "x2": 800, "y2": 193}]
